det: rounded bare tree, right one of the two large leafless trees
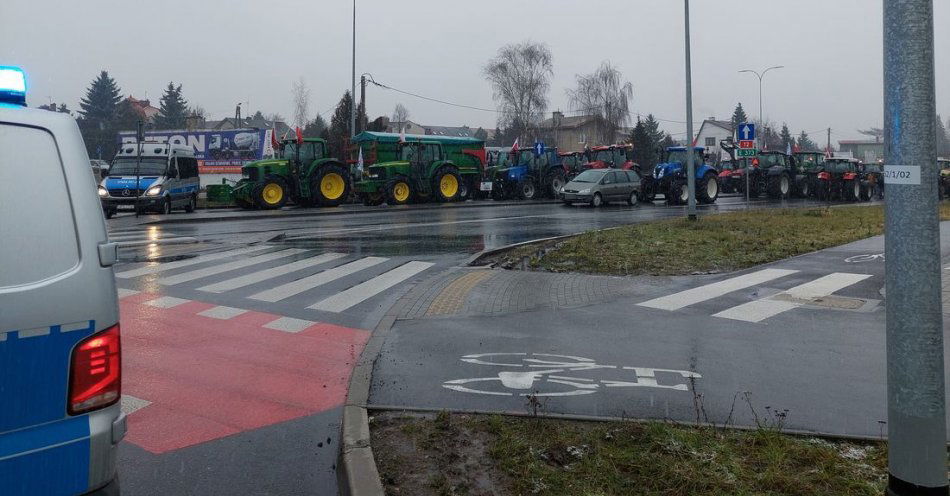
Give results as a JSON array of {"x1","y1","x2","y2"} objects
[{"x1": 567, "y1": 61, "x2": 633, "y2": 145}]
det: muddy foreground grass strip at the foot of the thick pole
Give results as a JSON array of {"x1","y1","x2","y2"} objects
[{"x1": 371, "y1": 412, "x2": 887, "y2": 496}]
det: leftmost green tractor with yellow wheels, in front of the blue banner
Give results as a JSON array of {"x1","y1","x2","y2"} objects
[{"x1": 234, "y1": 138, "x2": 351, "y2": 210}]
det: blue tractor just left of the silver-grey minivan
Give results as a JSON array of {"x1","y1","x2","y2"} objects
[{"x1": 489, "y1": 147, "x2": 567, "y2": 200}]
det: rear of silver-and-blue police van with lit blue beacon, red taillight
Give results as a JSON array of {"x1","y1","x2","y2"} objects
[{"x1": 0, "y1": 67, "x2": 126, "y2": 496}]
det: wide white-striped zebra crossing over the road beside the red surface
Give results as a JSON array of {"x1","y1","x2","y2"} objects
[{"x1": 115, "y1": 245, "x2": 435, "y2": 312}]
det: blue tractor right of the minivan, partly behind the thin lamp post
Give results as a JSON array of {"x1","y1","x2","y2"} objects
[{"x1": 640, "y1": 146, "x2": 719, "y2": 205}]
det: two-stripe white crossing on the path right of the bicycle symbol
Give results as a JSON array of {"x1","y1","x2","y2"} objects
[{"x1": 637, "y1": 268, "x2": 871, "y2": 323}]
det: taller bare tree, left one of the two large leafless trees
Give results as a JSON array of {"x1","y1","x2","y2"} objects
[{"x1": 484, "y1": 41, "x2": 554, "y2": 139}]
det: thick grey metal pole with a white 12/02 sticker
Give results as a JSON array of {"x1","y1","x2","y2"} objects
[{"x1": 884, "y1": 0, "x2": 948, "y2": 496}]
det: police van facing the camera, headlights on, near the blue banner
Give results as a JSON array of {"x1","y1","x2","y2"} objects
[{"x1": 99, "y1": 141, "x2": 199, "y2": 218}]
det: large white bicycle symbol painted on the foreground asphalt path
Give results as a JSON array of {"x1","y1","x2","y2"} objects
[{"x1": 442, "y1": 353, "x2": 702, "y2": 396}]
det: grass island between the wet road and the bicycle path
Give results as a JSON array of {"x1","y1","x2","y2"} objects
[{"x1": 496, "y1": 203, "x2": 950, "y2": 275}]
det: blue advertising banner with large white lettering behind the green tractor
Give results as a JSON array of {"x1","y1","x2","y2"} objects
[{"x1": 117, "y1": 129, "x2": 273, "y2": 174}]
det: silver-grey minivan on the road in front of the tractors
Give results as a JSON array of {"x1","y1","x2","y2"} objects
[{"x1": 559, "y1": 169, "x2": 640, "y2": 207}]
